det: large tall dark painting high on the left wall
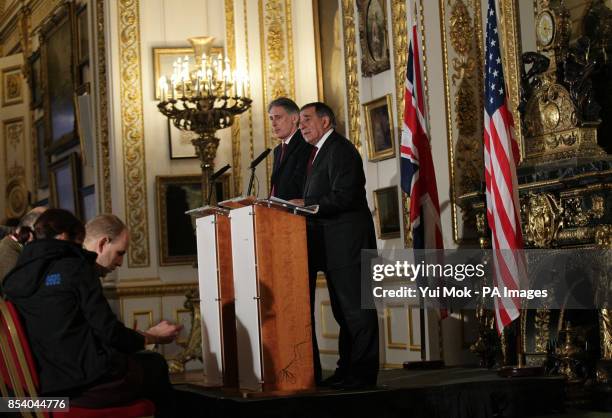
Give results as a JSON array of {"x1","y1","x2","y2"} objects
[{"x1": 41, "y1": 2, "x2": 78, "y2": 154}]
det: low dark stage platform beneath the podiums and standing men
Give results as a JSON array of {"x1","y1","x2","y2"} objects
[{"x1": 173, "y1": 368, "x2": 565, "y2": 418}]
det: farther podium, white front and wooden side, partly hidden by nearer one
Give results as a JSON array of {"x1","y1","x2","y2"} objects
[{"x1": 196, "y1": 207, "x2": 238, "y2": 388}]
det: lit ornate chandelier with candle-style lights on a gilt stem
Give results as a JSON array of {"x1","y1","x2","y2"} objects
[{"x1": 157, "y1": 36, "x2": 252, "y2": 204}]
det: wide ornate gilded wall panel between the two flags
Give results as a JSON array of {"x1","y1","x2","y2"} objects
[{"x1": 439, "y1": 0, "x2": 484, "y2": 243}]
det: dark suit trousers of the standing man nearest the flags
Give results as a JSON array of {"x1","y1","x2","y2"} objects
[{"x1": 310, "y1": 264, "x2": 379, "y2": 385}]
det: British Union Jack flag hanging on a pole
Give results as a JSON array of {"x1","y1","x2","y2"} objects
[{"x1": 400, "y1": 3, "x2": 444, "y2": 249}]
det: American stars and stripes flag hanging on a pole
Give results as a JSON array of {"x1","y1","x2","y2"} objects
[{"x1": 484, "y1": 0, "x2": 524, "y2": 333}]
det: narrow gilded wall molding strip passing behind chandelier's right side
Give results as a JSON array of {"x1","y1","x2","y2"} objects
[{"x1": 225, "y1": 0, "x2": 242, "y2": 196}]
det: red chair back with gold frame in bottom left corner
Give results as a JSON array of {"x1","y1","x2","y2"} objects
[{"x1": 0, "y1": 298, "x2": 48, "y2": 418}]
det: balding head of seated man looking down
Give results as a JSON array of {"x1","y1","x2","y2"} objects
[{"x1": 83, "y1": 214, "x2": 130, "y2": 272}]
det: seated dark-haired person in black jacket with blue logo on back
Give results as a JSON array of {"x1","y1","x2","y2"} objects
[{"x1": 3, "y1": 209, "x2": 181, "y2": 416}]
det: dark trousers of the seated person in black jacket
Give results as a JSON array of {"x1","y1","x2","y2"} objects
[{"x1": 70, "y1": 351, "x2": 175, "y2": 417}]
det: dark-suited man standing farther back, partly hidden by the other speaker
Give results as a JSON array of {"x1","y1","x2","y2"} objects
[{"x1": 268, "y1": 97, "x2": 312, "y2": 200}]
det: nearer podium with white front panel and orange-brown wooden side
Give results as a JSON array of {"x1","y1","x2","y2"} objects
[{"x1": 230, "y1": 202, "x2": 314, "y2": 392}]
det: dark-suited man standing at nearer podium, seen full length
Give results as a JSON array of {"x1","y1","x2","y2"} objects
[{"x1": 293, "y1": 102, "x2": 379, "y2": 389}]
